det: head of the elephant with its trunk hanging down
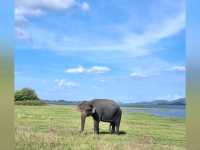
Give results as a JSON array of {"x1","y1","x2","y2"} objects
[{"x1": 78, "y1": 101, "x2": 96, "y2": 132}]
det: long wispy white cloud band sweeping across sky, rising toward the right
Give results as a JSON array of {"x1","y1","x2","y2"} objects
[{"x1": 16, "y1": 9, "x2": 185, "y2": 57}]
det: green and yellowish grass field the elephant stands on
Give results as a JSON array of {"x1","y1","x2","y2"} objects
[{"x1": 15, "y1": 105, "x2": 186, "y2": 150}]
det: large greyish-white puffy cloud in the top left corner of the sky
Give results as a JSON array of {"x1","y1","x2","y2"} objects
[{"x1": 15, "y1": 0, "x2": 90, "y2": 39}]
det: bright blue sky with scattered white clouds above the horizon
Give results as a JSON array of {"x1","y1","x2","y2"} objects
[{"x1": 15, "y1": 0, "x2": 186, "y2": 102}]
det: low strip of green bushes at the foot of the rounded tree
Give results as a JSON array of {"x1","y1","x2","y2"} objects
[{"x1": 15, "y1": 100, "x2": 47, "y2": 106}]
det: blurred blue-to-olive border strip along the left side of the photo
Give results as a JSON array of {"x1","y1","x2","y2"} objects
[{"x1": 0, "y1": 0, "x2": 15, "y2": 150}]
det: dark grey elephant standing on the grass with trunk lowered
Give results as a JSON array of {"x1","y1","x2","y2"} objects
[{"x1": 78, "y1": 99, "x2": 122, "y2": 134}]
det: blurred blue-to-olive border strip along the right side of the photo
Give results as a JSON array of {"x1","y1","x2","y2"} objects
[{"x1": 186, "y1": 0, "x2": 200, "y2": 150}]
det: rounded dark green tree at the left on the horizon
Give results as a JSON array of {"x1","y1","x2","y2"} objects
[{"x1": 15, "y1": 88, "x2": 40, "y2": 101}]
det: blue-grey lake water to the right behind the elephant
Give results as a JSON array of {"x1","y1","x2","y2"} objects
[{"x1": 122, "y1": 107, "x2": 185, "y2": 118}]
